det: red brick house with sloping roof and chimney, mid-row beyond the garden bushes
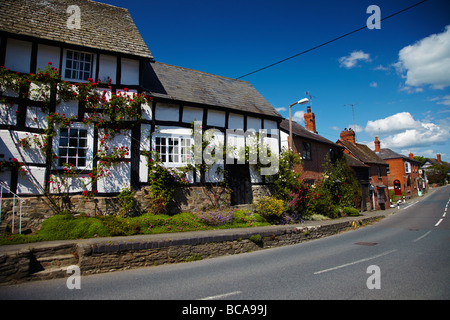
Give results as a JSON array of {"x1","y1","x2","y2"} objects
[{"x1": 337, "y1": 129, "x2": 389, "y2": 211}]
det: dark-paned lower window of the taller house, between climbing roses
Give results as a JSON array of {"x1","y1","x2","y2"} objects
[{"x1": 58, "y1": 128, "x2": 88, "y2": 168}]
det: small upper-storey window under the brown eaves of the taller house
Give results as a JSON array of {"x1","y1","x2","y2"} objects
[{"x1": 64, "y1": 50, "x2": 94, "y2": 81}]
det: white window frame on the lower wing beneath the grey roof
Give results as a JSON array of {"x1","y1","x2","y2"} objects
[{"x1": 152, "y1": 134, "x2": 194, "y2": 167}]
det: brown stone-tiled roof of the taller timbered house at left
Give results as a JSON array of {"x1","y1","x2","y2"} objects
[{"x1": 0, "y1": 0, "x2": 153, "y2": 59}]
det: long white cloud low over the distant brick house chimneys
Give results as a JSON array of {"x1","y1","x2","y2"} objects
[{"x1": 365, "y1": 112, "x2": 450, "y2": 150}]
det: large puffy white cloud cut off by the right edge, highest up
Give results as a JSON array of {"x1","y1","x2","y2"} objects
[{"x1": 396, "y1": 25, "x2": 450, "y2": 89}]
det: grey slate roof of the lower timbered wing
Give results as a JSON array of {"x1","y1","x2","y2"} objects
[{"x1": 144, "y1": 62, "x2": 281, "y2": 118}]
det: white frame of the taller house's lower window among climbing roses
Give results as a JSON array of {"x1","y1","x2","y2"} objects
[{"x1": 53, "y1": 123, "x2": 94, "y2": 170}]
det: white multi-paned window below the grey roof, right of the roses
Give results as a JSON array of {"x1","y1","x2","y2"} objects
[{"x1": 155, "y1": 137, "x2": 191, "y2": 164}]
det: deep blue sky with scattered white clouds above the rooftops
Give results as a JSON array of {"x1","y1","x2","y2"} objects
[{"x1": 97, "y1": 0, "x2": 450, "y2": 161}]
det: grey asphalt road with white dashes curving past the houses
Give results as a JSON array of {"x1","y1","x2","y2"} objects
[{"x1": 0, "y1": 186, "x2": 450, "y2": 301}]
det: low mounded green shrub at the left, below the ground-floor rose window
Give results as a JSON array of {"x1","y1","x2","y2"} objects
[{"x1": 37, "y1": 214, "x2": 110, "y2": 241}]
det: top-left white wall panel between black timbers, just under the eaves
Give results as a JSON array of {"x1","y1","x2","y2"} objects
[{"x1": 5, "y1": 38, "x2": 31, "y2": 73}]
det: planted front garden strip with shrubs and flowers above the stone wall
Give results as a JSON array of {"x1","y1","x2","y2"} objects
[{"x1": 0, "y1": 152, "x2": 360, "y2": 245}]
